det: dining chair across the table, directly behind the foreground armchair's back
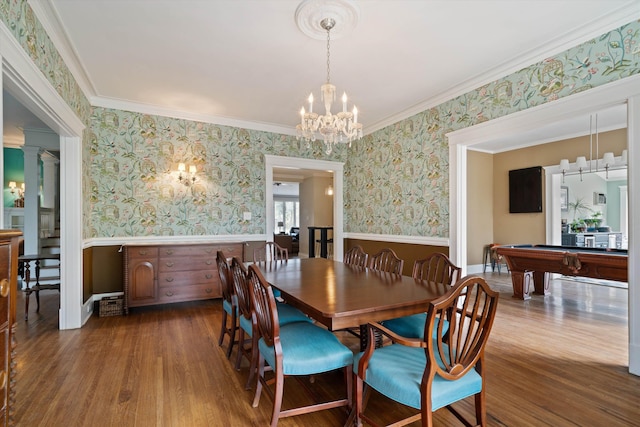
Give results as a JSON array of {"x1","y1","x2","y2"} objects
[{"x1": 382, "y1": 252, "x2": 461, "y2": 338}]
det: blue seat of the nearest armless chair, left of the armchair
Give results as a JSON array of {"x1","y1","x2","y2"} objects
[{"x1": 258, "y1": 322, "x2": 353, "y2": 375}]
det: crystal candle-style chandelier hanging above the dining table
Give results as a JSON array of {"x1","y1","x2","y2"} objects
[{"x1": 296, "y1": 18, "x2": 362, "y2": 154}]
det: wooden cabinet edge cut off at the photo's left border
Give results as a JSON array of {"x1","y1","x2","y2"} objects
[{"x1": 0, "y1": 230, "x2": 22, "y2": 426}]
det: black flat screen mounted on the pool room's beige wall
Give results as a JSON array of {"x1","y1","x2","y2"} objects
[{"x1": 509, "y1": 166, "x2": 542, "y2": 213}]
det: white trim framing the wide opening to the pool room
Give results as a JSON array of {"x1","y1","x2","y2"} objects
[{"x1": 447, "y1": 75, "x2": 640, "y2": 375}]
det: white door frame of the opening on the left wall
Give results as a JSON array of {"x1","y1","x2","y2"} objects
[{"x1": 0, "y1": 23, "x2": 85, "y2": 329}]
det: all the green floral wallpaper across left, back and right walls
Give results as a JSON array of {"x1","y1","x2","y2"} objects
[{"x1": 0, "y1": 0, "x2": 640, "y2": 238}]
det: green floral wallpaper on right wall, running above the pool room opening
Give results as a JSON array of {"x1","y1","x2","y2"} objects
[{"x1": 345, "y1": 21, "x2": 640, "y2": 237}]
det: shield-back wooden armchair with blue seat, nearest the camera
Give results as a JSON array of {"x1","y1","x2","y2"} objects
[{"x1": 354, "y1": 276, "x2": 499, "y2": 426}]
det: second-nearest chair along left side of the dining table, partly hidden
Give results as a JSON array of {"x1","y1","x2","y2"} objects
[{"x1": 231, "y1": 257, "x2": 311, "y2": 390}]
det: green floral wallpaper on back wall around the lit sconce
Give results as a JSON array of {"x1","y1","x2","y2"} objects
[{"x1": 88, "y1": 108, "x2": 346, "y2": 237}]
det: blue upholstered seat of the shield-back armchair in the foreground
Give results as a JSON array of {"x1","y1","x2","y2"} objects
[{"x1": 354, "y1": 344, "x2": 482, "y2": 411}]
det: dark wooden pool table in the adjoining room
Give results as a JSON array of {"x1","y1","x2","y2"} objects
[{"x1": 496, "y1": 245, "x2": 628, "y2": 299}]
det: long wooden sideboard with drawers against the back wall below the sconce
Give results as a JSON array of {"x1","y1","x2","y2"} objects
[{"x1": 124, "y1": 242, "x2": 244, "y2": 314}]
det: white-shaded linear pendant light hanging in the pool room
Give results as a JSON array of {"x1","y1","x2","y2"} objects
[{"x1": 559, "y1": 114, "x2": 627, "y2": 182}]
